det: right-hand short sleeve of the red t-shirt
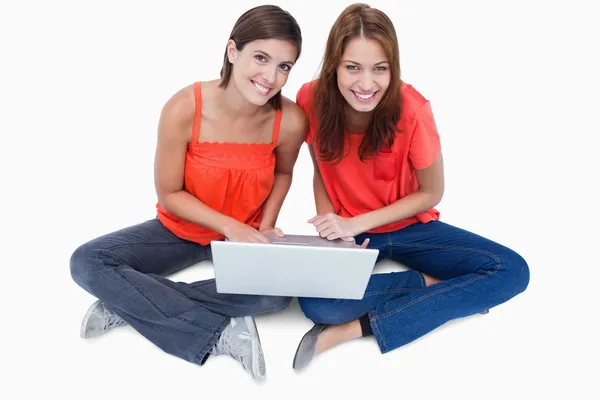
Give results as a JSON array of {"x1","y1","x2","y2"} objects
[{"x1": 408, "y1": 102, "x2": 442, "y2": 169}]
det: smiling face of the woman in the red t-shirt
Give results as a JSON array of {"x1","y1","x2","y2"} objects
[{"x1": 337, "y1": 37, "x2": 390, "y2": 112}]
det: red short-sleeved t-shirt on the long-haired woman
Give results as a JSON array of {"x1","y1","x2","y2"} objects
[{"x1": 296, "y1": 81, "x2": 441, "y2": 233}]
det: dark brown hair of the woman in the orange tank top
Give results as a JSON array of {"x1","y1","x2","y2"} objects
[{"x1": 219, "y1": 5, "x2": 302, "y2": 110}]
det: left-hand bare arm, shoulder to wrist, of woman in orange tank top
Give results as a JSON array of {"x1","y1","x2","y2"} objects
[{"x1": 154, "y1": 86, "x2": 262, "y2": 241}]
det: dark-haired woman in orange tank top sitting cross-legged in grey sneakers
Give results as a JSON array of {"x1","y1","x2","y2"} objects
[{"x1": 71, "y1": 6, "x2": 306, "y2": 378}]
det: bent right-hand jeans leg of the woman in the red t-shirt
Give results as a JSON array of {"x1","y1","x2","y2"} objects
[{"x1": 369, "y1": 221, "x2": 529, "y2": 353}]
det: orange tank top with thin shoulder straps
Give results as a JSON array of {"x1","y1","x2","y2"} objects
[{"x1": 156, "y1": 82, "x2": 281, "y2": 245}]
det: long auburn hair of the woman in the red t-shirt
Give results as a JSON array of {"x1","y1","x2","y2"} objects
[{"x1": 313, "y1": 4, "x2": 402, "y2": 162}]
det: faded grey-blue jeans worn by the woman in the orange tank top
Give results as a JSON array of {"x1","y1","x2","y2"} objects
[{"x1": 71, "y1": 219, "x2": 291, "y2": 365}]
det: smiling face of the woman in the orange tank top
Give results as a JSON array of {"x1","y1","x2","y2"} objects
[{"x1": 227, "y1": 39, "x2": 297, "y2": 106}]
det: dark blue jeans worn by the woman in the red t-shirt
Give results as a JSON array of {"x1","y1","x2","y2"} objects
[{"x1": 299, "y1": 221, "x2": 529, "y2": 353}]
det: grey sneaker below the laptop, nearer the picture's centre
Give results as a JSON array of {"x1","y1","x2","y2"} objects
[{"x1": 211, "y1": 317, "x2": 266, "y2": 379}]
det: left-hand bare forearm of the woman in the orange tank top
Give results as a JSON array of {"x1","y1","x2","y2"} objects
[{"x1": 159, "y1": 190, "x2": 238, "y2": 235}]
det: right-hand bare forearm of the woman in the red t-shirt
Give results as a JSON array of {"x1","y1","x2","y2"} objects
[{"x1": 353, "y1": 191, "x2": 441, "y2": 233}]
